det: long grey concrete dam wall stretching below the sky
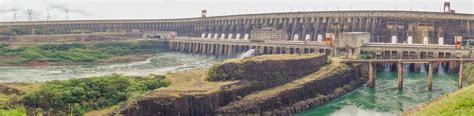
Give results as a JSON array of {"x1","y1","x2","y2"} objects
[{"x1": 0, "y1": 11, "x2": 474, "y2": 44}]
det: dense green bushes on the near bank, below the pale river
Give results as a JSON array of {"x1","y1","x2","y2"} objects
[{"x1": 22, "y1": 74, "x2": 170, "y2": 115}]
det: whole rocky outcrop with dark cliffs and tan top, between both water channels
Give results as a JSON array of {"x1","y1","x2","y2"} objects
[{"x1": 114, "y1": 55, "x2": 363, "y2": 116}]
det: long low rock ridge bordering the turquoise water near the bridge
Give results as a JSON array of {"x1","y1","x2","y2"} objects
[{"x1": 216, "y1": 66, "x2": 366, "y2": 115}]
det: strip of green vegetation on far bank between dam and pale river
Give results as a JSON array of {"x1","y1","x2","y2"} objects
[{"x1": 0, "y1": 41, "x2": 167, "y2": 64}]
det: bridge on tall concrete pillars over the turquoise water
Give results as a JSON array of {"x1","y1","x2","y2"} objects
[{"x1": 341, "y1": 58, "x2": 474, "y2": 91}]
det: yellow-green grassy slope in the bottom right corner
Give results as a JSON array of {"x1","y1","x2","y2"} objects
[{"x1": 414, "y1": 85, "x2": 474, "y2": 116}]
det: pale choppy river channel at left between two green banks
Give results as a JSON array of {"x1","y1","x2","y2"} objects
[{"x1": 0, "y1": 52, "x2": 222, "y2": 82}]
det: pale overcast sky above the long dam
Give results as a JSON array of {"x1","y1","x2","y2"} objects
[{"x1": 0, "y1": 0, "x2": 474, "y2": 21}]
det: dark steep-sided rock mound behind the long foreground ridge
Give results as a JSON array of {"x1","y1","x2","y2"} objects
[{"x1": 209, "y1": 56, "x2": 327, "y2": 88}]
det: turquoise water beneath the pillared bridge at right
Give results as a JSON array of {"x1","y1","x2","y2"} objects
[{"x1": 297, "y1": 71, "x2": 457, "y2": 116}]
